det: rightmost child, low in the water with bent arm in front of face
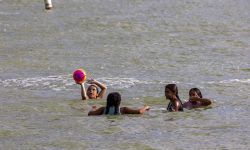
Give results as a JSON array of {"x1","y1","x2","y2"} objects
[{"x1": 183, "y1": 88, "x2": 212, "y2": 109}]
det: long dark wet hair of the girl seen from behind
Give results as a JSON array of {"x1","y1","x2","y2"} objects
[{"x1": 105, "y1": 92, "x2": 121, "y2": 115}]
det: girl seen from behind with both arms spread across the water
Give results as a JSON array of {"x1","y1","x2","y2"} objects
[{"x1": 88, "y1": 92, "x2": 149, "y2": 116}]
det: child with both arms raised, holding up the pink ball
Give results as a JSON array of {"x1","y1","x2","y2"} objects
[{"x1": 77, "y1": 79, "x2": 107, "y2": 100}]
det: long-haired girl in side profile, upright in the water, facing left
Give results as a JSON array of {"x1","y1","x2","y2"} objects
[{"x1": 165, "y1": 84, "x2": 183, "y2": 112}]
